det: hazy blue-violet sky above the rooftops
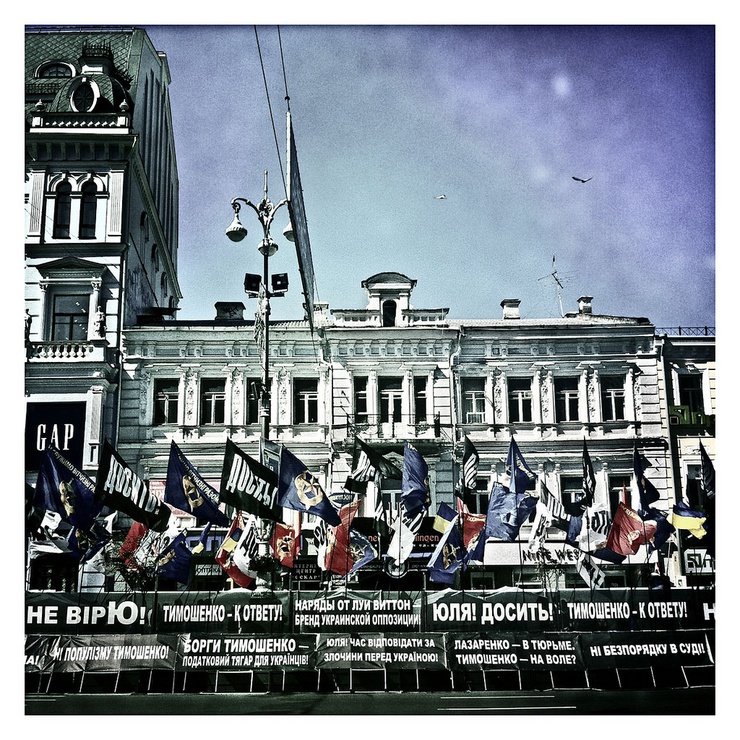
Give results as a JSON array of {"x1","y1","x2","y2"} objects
[{"x1": 140, "y1": 23, "x2": 715, "y2": 327}]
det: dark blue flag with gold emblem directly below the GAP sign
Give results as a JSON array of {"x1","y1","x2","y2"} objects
[{"x1": 33, "y1": 447, "x2": 103, "y2": 529}]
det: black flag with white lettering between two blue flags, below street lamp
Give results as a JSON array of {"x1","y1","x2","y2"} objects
[{"x1": 219, "y1": 439, "x2": 280, "y2": 522}]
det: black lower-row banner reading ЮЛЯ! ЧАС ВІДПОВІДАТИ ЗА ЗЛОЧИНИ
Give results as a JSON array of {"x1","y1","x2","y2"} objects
[{"x1": 316, "y1": 632, "x2": 448, "y2": 671}]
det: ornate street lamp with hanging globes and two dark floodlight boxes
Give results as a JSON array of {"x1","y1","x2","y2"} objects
[{"x1": 226, "y1": 172, "x2": 293, "y2": 587}]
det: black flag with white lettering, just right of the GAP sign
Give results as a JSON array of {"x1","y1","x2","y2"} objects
[{"x1": 95, "y1": 440, "x2": 170, "y2": 532}]
